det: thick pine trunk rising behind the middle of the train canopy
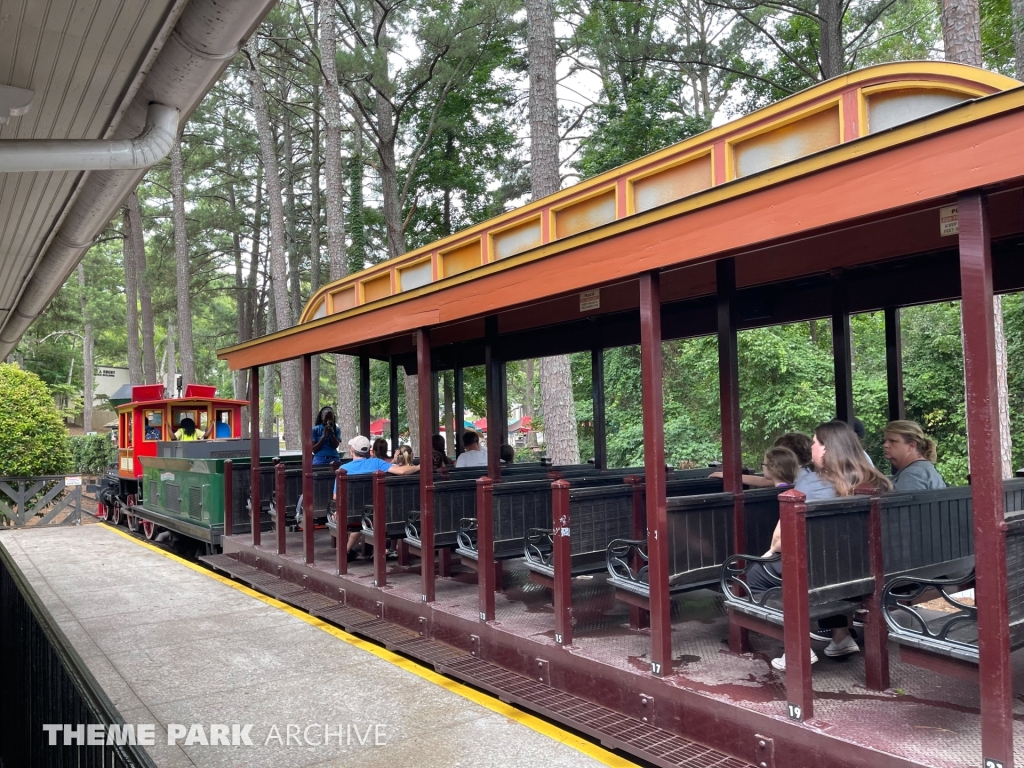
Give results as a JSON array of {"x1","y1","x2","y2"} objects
[{"x1": 526, "y1": 0, "x2": 580, "y2": 464}]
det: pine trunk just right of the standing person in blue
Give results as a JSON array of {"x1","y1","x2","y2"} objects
[{"x1": 319, "y1": 0, "x2": 359, "y2": 441}]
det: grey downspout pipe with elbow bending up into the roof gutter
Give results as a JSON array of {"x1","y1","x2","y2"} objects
[{"x1": 0, "y1": 103, "x2": 178, "y2": 173}]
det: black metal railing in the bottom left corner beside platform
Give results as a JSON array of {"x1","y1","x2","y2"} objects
[{"x1": 0, "y1": 547, "x2": 156, "y2": 768}]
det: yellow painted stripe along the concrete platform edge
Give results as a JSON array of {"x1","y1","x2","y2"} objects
[{"x1": 102, "y1": 525, "x2": 636, "y2": 768}]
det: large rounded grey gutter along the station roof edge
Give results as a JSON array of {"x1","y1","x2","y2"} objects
[{"x1": 0, "y1": 0, "x2": 274, "y2": 359}]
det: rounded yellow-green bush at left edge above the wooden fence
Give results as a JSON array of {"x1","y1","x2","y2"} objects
[{"x1": 0, "y1": 362, "x2": 71, "y2": 477}]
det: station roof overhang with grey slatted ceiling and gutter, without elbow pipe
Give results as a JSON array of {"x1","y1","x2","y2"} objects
[{"x1": 0, "y1": 0, "x2": 273, "y2": 359}]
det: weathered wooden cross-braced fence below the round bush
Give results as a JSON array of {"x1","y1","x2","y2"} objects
[{"x1": 0, "y1": 475, "x2": 82, "y2": 528}]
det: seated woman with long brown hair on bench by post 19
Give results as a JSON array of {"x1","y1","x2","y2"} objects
[{"x1": 746, "y1": 421, "x2": 892, "y2": 672}]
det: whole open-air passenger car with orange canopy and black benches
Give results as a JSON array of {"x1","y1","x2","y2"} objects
[{"x1": 210, "y1": 62, "x2": 1024, "y2": 768}]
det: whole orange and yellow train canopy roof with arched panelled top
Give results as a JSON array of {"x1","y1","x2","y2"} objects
[{"x1": 218, "y1": 61, "x2": 1024, "y2": 371}]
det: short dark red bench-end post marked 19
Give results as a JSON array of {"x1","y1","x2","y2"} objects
[{"x1": 778, "y1": 489, "x2": 814, "y2": 721}]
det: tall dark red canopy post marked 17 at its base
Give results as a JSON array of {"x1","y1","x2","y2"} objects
[{"x1": 640, "y1": 272, "x2": 672, "y2": 676}]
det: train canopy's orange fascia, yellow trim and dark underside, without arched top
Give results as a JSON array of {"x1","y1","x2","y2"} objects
[{"x1": 218, "y1": 70, "x2": 1024, "y2": 371}]
